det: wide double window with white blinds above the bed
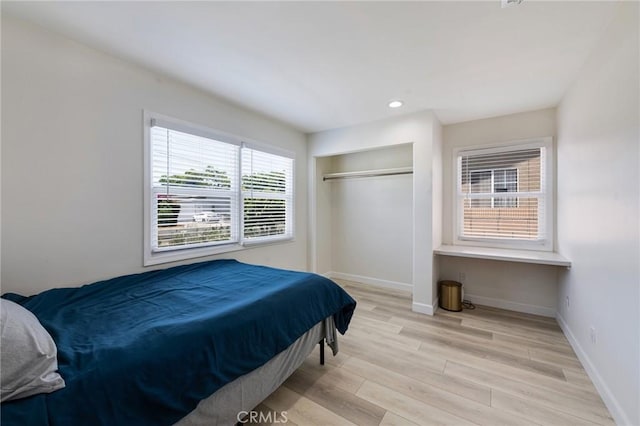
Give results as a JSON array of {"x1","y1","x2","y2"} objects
[{"x1": 145, "y1": 113, "x2": 294, "y2": 265}]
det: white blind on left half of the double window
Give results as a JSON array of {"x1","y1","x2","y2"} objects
[{"x1": 150, "y1": 123, "x2": 240, "y2": 252}]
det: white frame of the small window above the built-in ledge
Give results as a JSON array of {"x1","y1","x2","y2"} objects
[{"x1": 452, "y1": 137, "x2": 555, "y2": 251}]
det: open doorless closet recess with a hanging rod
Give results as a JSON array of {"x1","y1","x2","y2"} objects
[{"x1": 315, "y1": 144, "x2": 414, "y2": 292}]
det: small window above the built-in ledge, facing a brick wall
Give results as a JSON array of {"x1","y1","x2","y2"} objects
[{"x1": 455, "y1": 138, "x2": 553, "y2": 250}]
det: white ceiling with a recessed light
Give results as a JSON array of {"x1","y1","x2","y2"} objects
[{"x1": 2, "y1": 0, "x2": 617, "y2": 132}]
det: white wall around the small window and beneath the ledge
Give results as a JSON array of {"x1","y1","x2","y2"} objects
[{"x1": 438, "y1": 108, "x2": 557, "y2": 316}]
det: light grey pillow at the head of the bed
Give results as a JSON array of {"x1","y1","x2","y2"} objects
[{"x1": 0, "y1": 299, "x2": 64, "y2": 402}]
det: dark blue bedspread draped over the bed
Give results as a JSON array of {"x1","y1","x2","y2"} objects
[{"x1": 1, "y1": 260, "x2": 355, "y2": 426}]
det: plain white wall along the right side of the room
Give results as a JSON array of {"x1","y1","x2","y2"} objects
[{"x1": 557, "y1": 2, "x2": 640, "y2": 425}]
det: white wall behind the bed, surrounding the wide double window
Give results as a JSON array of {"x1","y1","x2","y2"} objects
[{"x1": 2, "y1": 14, "x2": 307, "y2": 294}]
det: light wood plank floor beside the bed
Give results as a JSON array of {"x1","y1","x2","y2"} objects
[{"x1": 258, "y1": 281, "x2": 614, "y2": 426}]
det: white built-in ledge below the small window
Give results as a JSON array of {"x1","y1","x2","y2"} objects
[{"x1": 433, "y1": 245, "x2": 571, "y2": 268}]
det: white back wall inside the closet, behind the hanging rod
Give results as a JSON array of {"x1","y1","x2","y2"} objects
[{"x1": 323, "y1": 144, "x2": 413, "y2": 291}]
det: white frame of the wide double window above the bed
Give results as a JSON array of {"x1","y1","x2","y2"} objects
[{"x1": 143, "y1": 110, "x2": 296, "y2": 266}]
